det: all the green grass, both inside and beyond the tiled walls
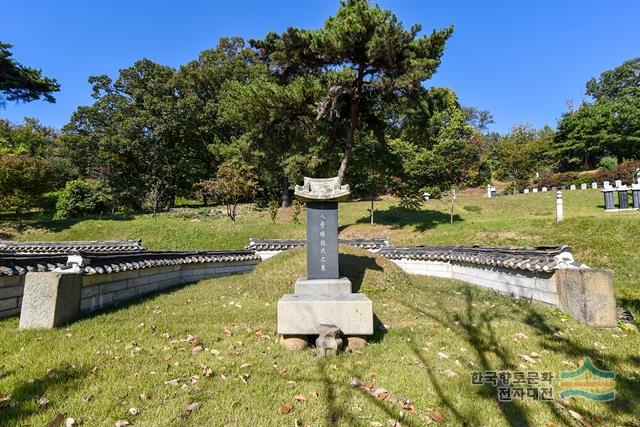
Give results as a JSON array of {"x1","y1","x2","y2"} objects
[{"x1": 0, "y1": 195, "x2": 640, "y2": 426}]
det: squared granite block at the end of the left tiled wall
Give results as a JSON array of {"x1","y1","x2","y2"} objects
[{"x1": 20, "y1": 272, "x2": 82, "y2": 329}]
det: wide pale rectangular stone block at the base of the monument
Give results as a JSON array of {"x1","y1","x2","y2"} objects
[{"x1": 278, "y1": 294, "x2": 373, "y2": 335}]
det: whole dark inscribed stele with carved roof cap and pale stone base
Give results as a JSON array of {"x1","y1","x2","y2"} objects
[{"x1": 278, "y1": 177, "x2": 373, "y2": 355}]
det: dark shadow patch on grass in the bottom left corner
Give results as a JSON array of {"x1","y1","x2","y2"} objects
[{"x1": 0, "y1": 366, "x2": 89, "y2": 426}]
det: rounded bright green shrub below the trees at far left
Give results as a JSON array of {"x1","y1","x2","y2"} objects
[{"x1": 55, "y1": 179, "x2": 111, "y2": 219}]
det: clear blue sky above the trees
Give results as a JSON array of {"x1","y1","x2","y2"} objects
[{"x1": 0, "y1": 0, "x2": 640, "y2": 132}]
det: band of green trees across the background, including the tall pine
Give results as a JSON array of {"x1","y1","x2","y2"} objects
[{"x1": 0, "y1": 0, "x2": 640, "y2": 221}]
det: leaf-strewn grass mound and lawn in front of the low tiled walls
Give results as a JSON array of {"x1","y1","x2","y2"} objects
[{"x1": 0, "y1": 248, "x2": 640, "y2": 426}]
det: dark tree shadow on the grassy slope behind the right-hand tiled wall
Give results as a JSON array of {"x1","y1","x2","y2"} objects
[{"x1": 356, "y1": 206, "x2": 463, "y2": 231}]
